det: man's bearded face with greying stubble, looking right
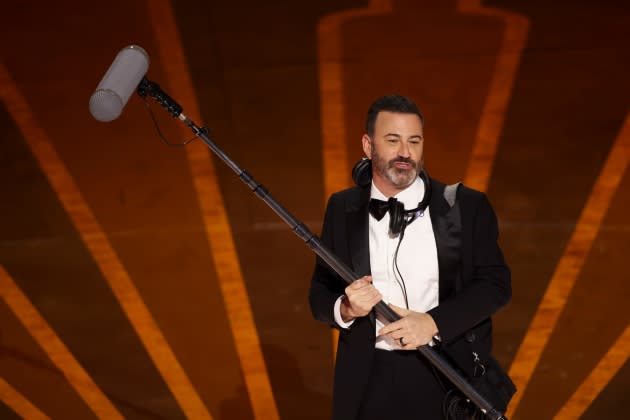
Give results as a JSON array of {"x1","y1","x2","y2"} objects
[{"x1": 363, "y1": 111, "x2": 424, "y2": 196}]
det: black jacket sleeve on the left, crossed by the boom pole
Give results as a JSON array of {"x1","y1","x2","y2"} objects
[{"x1": 309, "y1": 194, "x2": 346, "y2": 328}]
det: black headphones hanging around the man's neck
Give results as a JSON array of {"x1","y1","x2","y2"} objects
[{"x1": 352, "y1": 158, "x2": 431, "y2": 236}]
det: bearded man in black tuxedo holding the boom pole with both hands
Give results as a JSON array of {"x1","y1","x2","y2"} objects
[{"x1": 309, "y1": 95, "x2": 511, "y2": 420}]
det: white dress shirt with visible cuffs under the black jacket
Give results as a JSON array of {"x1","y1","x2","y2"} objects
[{"x1": 334, "y1": 178, "x2": 439, "y2": 350}]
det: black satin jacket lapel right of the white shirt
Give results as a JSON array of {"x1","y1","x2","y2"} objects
[{"x1": 430, "y1": 181, "x2": 461, "y2": 302}]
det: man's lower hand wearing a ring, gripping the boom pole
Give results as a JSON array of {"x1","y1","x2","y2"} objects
[{"x1": 378, "y1": 304, "x2": 438, "y2": 350}]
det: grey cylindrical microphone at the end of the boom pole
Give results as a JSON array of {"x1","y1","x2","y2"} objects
[{"x1": 90, "y1": 45, "x2": 149, "y2": 122}]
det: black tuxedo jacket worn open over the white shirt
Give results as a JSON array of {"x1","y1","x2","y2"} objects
[{"x1": 309, "y1": 180, "x2": 511, "y2": 420}]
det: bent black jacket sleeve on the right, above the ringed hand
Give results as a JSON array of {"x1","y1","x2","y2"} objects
[{"x1": 428, "y1": 193, "x2": 512, "y2": 343}]
